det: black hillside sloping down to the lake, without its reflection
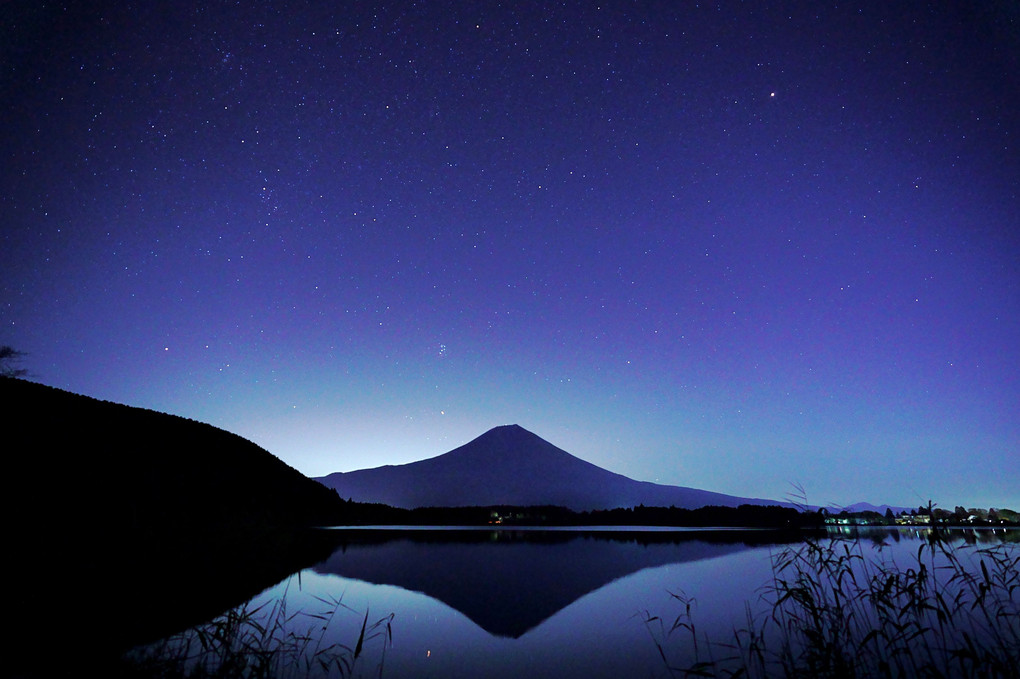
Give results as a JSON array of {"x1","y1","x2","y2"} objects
[{"x1": 0, "y1": 379, "x2": 341, "y2": 532}]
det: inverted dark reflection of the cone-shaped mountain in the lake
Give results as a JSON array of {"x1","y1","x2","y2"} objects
[{"x1": 314, "y1": 530, "x2": 796, "y2": 638}]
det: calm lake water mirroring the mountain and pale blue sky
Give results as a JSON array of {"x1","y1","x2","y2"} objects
[{"x1": 131, "y1": 527, "x2": 1020, "y2": 678}]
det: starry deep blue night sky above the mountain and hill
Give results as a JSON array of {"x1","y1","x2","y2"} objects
[{"x1": 0, "y1": 1, "x2": 1020, "y2": 509}]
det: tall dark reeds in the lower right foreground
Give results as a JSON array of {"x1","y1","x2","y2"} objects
[{"x1": 645, "y1": 531, "x2": 1020, "y2": 678}]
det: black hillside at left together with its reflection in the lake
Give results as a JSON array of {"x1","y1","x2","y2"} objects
[{"x1": 0, "y1": 379, "x2": 344, "y2": 662}]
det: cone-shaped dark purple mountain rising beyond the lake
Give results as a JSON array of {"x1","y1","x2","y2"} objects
[{"x1": 315, "y1": 424, "x2": 780, "y2": 512}]
